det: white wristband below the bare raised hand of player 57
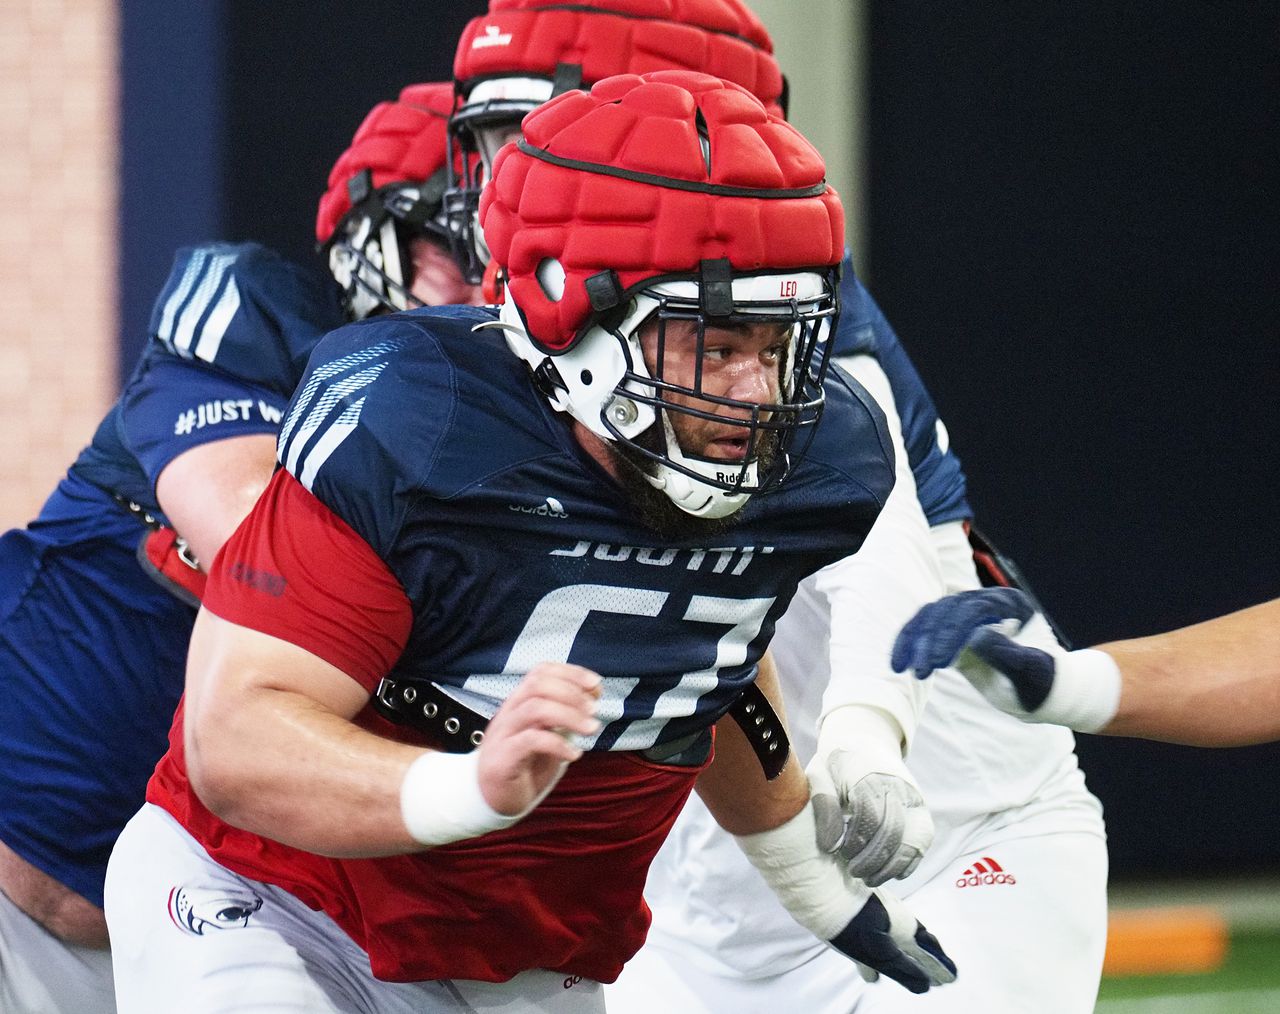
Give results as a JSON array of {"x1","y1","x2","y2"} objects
[{"x1": 401, "y1": 750, "x2": 527, "y2": 848}]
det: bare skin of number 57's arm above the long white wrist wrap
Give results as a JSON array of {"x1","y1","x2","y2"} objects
[{"x1": 696, "y1": 654, "x2": 809, "y2": 835}]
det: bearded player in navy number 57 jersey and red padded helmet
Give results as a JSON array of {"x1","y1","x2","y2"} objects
[{"x1": 106, "y1": 72, "x2": 954, "y2": 1011}]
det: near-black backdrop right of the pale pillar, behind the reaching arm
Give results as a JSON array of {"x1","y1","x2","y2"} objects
[{"x1": 868, "y1": 0, "x2": 1280, "y2": 876}]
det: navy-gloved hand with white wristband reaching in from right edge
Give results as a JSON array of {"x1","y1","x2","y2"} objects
[{"x1": 892, "y1": 588, "x2": 1120, "y2": 732}]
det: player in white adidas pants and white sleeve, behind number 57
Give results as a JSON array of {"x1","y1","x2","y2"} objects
[{"x1": 445, "y1": 0, "x2": 1107, "y2": 1011}]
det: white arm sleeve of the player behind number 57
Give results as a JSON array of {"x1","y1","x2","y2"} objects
[{"x1": 814, "y1": 356, "x2": 952, "y2": 748}]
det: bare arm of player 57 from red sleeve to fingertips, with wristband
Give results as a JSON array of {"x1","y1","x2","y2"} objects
[{"x1": 183, "y1": 609, "x2": 600, "y2": 857}]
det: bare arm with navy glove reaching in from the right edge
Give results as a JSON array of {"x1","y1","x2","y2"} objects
[{"x1": 893, "y1": 589, "x2": 1280, "y2": 746}]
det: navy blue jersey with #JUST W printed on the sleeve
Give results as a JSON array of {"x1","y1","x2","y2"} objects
[{"x1": 0, "y1": 245, "x2": 343, "y2": 905}]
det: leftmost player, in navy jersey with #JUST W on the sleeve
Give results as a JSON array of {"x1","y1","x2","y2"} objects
[{"x1": 0, "y1": 85, "x2": 476, "y2": 1014}]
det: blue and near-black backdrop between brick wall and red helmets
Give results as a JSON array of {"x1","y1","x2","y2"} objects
[{"x1": 120, "y1": 0, "x2": 488, "y2": 375}]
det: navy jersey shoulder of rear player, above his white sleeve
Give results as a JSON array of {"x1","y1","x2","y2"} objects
[{"x1": 832, "y1": 256, "x2": 973, "y2": 525}]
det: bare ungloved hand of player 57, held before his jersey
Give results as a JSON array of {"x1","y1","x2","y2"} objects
[{"x1": 477, "y1": 662, "x2": 600, "y2": 816}]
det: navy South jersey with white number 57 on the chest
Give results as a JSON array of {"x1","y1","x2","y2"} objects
[{"x1": 279, "y1": 307, "x2": 893, "y2": 750}]
